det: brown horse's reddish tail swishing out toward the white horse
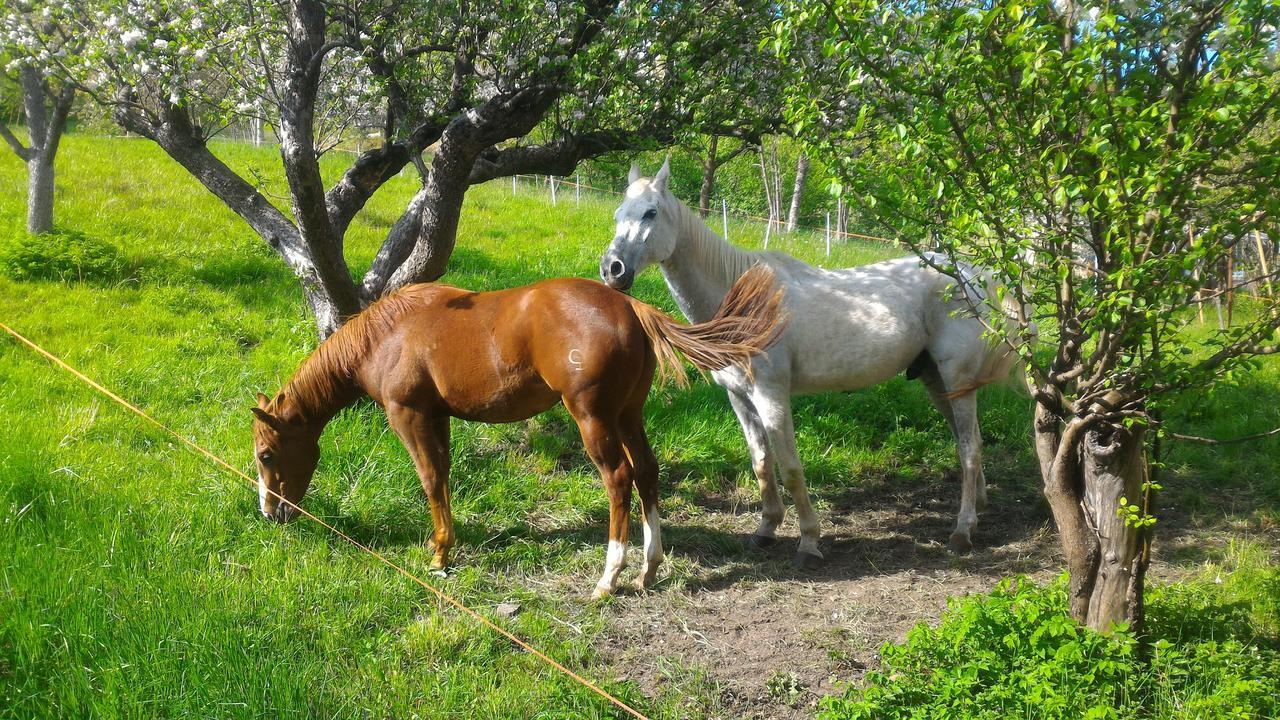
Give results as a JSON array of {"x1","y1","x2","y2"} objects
[{"x1": 628, "y1": 264, "x2": 787, "y2": 386}]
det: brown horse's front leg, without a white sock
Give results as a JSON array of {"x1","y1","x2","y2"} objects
[{"x1": 387, "y1": 404, "x2": 453, "y2": 570}]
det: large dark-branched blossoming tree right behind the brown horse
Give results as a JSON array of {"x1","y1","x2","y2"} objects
[{"x1": 24, "y1": 0, "x2": 767, "y2": 336}]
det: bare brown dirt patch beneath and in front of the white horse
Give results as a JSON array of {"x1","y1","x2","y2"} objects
[{"x1": 586, "y1": 471, "x2": 1269, "y2": 719}]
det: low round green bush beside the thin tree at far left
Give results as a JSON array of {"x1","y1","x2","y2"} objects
[{"x1": 0, "y1": 225, "x2": 125, "y2": 281}]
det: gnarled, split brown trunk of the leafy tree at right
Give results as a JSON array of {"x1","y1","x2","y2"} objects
[{"x1": 1036, "y1": 405, "x2": 1148, "y2": 633}]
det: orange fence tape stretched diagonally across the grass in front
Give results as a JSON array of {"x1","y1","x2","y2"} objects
[{"x1": 0, "y1": 323, "x2": 649, "y2": 720}]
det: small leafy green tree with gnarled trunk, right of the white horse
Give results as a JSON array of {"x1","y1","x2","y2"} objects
[{"x1": 776, "y1": 0, "x2": 1280, "y2": 630}]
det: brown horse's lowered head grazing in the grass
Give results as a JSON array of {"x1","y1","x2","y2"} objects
[{"x1": 253, "y1": 393, "x2": 320, "y2": 523}]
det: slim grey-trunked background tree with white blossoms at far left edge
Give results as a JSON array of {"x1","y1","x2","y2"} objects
[{"x1": 0, "y1": 6, "x2": 82, "y2": 234}]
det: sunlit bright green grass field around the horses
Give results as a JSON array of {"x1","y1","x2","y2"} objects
[{"x1": 0, "y1": 136, "x2": 1280, "y2": 719}]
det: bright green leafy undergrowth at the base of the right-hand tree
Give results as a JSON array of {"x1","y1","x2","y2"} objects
[{"x1": 819, "y1": 558, "x2": 1280, "y2": 720}]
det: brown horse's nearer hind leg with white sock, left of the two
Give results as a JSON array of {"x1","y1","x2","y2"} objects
[{"x1": 564, "y1": 397, "x2": 632, "y2": 598}]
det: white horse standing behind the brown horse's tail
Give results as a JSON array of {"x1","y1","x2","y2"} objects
[{"x1": 600, "y1": 163, "x2": 1015, "y2": 566}]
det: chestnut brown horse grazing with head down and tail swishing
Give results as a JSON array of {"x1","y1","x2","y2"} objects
[{"x1": 253, "y1": 266, "x2": 783, "y2": 597}]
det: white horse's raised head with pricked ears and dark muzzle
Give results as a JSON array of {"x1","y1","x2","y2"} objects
[{"x1": 600, "y1": 158, "x2": 680, "y2": 292}]
